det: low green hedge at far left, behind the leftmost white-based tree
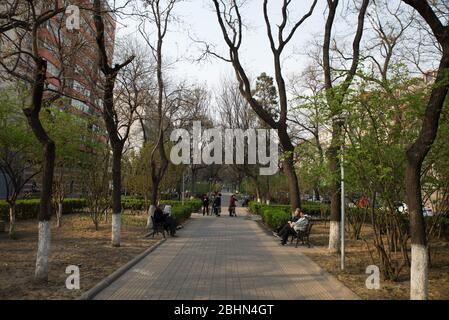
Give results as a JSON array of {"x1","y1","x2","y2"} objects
[{"x1": 0, "y1": 198, "x2": 86, "y2": 220}]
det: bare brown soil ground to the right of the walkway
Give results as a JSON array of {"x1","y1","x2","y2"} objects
[{"x1": 298, "y1": 222, "x2": 449, "y2": 300}]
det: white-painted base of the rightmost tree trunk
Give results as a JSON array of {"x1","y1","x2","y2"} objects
[{"x1": 410, "y1": 244, "x2": 429, "y2": 300}]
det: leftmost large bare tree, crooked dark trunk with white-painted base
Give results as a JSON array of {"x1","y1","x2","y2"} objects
[{"x1": 0, "y1": 0, "x2": 66, "y2": 281}]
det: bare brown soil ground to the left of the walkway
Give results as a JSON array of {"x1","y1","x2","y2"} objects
[{"x1": 0, "y1": 214, "x2": 158, "y2": 299}]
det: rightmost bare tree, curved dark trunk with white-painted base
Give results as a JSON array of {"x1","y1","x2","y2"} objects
[{"x1": 403, "y1": 0, "x2": 449, "y2": 299}]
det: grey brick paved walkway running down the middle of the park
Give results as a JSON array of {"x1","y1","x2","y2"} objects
[{"x1": 95, "y1": 208, "x2": 357, "y2": 299}]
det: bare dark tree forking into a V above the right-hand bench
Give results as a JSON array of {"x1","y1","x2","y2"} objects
[{"x1": 211, "y1": 0, "x2": 317, "y2": 208}]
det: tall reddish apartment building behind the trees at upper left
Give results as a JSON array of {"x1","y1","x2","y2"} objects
[{"x1": 0, "y1": 0, "x2": 116, "y2": 199}]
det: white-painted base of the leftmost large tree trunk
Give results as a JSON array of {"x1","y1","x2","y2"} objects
[{"x1": 34, "y1": 221, "x2": 51, "y2": 281}]
